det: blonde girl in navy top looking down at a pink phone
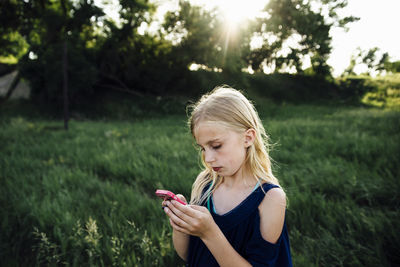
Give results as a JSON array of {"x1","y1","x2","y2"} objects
[{"x1": 163, "y1": 87, "x2": 292, "y2": 267}]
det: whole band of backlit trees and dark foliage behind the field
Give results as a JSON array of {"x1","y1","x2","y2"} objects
[{"x1": 0, "y1": 0, "x2": 362, "y2": 104}]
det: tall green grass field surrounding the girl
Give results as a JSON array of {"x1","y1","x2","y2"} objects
[{"x1": 0, "y1": 99, "x2": 400, "y2": 266}]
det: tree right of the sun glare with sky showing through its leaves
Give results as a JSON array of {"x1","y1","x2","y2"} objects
[{"x1": 247, "y1": 0, "x2": 358, "y2": 77}]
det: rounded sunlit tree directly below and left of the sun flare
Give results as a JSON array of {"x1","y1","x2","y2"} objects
[{"x1": 163, "y1": 1, "x2": 251, "y2": 75}]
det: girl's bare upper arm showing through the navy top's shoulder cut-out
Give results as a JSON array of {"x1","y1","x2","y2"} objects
[{"x1": 258, "y1": 188, "x2": 286, "y2": 244}]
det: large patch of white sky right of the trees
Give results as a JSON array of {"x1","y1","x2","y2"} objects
[{"x1": 328, "y1": 0, "x2": 400, "y2": 76}]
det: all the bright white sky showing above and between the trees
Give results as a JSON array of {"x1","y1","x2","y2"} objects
[{"x1": 95, "y1": 0, "x2": 400, "y2": 76}]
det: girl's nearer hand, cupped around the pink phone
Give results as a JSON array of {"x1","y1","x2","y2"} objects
[{"x1": 164, "y1": 200, "x2": 218, "y2": 239}]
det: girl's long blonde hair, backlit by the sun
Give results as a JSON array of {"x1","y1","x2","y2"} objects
[{"x1": 188, "y1": 86, "x2": 279, "y2": 205}]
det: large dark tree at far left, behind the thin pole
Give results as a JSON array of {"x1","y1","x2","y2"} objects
[{"x1": 0, "y1": 0, "x2": 104, "y2": 106}]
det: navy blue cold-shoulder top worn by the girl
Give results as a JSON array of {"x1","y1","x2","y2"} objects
[{"x1": 187, "y1": 183, "x2": 292, "y2": 267}]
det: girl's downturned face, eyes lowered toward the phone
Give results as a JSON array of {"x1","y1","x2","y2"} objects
[{"x1": 194, "y1": 122, "x2": 249, "y2": 181}]
